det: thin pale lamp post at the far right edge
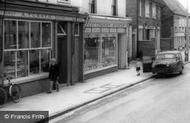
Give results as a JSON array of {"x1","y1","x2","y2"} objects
[{"x1": 185, "y1": 0, "x2": 189, "y2": 61}]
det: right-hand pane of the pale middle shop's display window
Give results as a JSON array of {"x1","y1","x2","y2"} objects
[{"x1": 102, "y1": 37, "x2": 116, "y2": 67}]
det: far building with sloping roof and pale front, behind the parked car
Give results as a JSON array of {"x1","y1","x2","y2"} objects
[{"x1": 161, "y1": 0, "x2": 187, "y2": 50}]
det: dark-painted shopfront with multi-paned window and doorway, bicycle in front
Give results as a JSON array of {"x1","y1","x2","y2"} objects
[{"x1": 0, "y1": 1, "x2": 85, "y2": 96}]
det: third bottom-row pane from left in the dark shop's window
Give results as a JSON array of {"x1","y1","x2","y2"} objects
[{"x1": 30, "y1": 50, "x2": 39, "y2": 74}]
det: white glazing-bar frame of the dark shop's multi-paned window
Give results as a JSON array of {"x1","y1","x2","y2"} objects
[{"x1": 2, "y1": 18, "x2": 53, "y2": 82}]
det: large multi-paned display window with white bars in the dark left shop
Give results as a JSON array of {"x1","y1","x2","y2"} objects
[{"x1": 3, "y1": 20, "x2": 52, "y2": 78}]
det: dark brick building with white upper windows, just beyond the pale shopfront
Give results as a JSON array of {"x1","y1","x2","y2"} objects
[{"x1": 126, "y1": 0, "x2": 162, "y2": 58}]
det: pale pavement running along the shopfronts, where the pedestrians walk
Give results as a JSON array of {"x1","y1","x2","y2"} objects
[{"x1": 0, "y1": 62, "x2": 152, "y2": 119}]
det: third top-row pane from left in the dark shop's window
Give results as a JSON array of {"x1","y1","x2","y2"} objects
[{"x1": 31, "y1": 22, "x2": 40, "y2": 48}]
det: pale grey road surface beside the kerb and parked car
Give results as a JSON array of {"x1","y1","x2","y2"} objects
[{"x1": 53, "y1": 64, "x2": 190, "y2": 123}]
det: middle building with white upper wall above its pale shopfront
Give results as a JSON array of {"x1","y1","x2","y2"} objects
[{"x1": 71, "y1": 0, "x2": 132, "y2": 79}]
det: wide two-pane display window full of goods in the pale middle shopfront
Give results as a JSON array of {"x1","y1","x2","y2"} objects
[{"x1": 84, "y1": 36, "x2": 117, "y2": 73}]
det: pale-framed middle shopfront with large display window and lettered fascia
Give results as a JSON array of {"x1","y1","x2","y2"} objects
[{"x1": 84, "y1": 16, "x2": 130, "y2": 78}]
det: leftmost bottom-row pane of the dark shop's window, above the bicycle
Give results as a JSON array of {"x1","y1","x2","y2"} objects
[{"x1": 4, "y1": 52, "x2": 16, "y2": 77}]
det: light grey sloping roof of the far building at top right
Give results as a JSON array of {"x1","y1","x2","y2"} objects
[{"x1": 163, "y1": 0, "x2": 186, "y2": 16}]
